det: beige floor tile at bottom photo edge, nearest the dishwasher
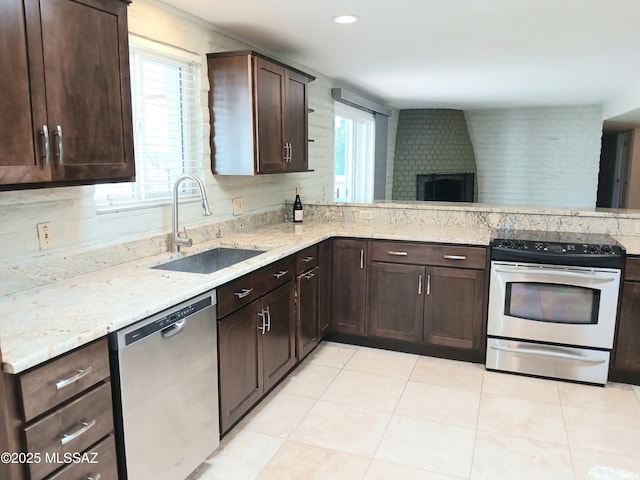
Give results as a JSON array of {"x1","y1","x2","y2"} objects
[{"x1": 196, "y1": 430, "x2": 284, "y2": 480}]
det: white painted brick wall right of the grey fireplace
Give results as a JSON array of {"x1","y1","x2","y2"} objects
[{"x1": 465, "y1": 106, "x2": 602, "y2": 209}]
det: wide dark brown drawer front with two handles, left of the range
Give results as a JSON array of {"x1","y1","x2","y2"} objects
[{"x1": 371, "y1": 241, "x2": 487, "y2": 269}]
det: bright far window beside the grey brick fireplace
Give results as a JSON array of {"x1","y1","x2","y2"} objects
[{"x1": 334, "y1": 102, "x2": 375, "y2": 202}]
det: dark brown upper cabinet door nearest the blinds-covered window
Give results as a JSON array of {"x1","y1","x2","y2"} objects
[{"x1": 37, "y1": 0, "x2": 135, "y2": 181}]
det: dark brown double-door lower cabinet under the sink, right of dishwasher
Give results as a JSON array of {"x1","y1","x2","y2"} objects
[{"x1": 218, "y1": 282, "x2": 296, "y2": 433}]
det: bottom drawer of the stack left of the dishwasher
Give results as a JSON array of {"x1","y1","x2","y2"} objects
[{"x1": 47, "y1": 435, "x2": 118, "y2": 480}]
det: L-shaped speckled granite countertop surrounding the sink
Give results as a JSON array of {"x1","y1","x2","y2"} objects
[{"x1": 0, "y1": 221, "x2": 491, "y2": 373}]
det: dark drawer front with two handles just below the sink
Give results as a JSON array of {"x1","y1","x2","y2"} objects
[{"x1": 218, "y1": 256, "x2": 295, "y2": 318}]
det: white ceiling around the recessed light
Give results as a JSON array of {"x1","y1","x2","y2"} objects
[{"x1": 163, "y1": 0, "x2": 640, "y2": 124}]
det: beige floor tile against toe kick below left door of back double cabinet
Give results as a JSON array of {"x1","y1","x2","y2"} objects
[{"x1": 344, "y1": 347, "x2": 418, "y2": 380}]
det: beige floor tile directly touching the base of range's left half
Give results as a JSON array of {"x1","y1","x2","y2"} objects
[{"x1": 482, "y1": 372, "x2": 560, "y2": 404}]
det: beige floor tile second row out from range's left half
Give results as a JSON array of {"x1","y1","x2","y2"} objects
[{"x1": 478, "y1": 393, "x2": 567, "y2": 445}]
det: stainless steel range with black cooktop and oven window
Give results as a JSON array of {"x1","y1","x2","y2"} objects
[{"x1": 486, "y1": 231, "x2": 625, "y2": 385}]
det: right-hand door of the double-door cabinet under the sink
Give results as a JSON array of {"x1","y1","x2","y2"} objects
[{"x1": 260, "y1": 282, "x2": 296, "y2": 392}]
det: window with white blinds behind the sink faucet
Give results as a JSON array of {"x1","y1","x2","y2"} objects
[{"x1": 94, "y1": 37, "x2": 203, "y2": 212}]
